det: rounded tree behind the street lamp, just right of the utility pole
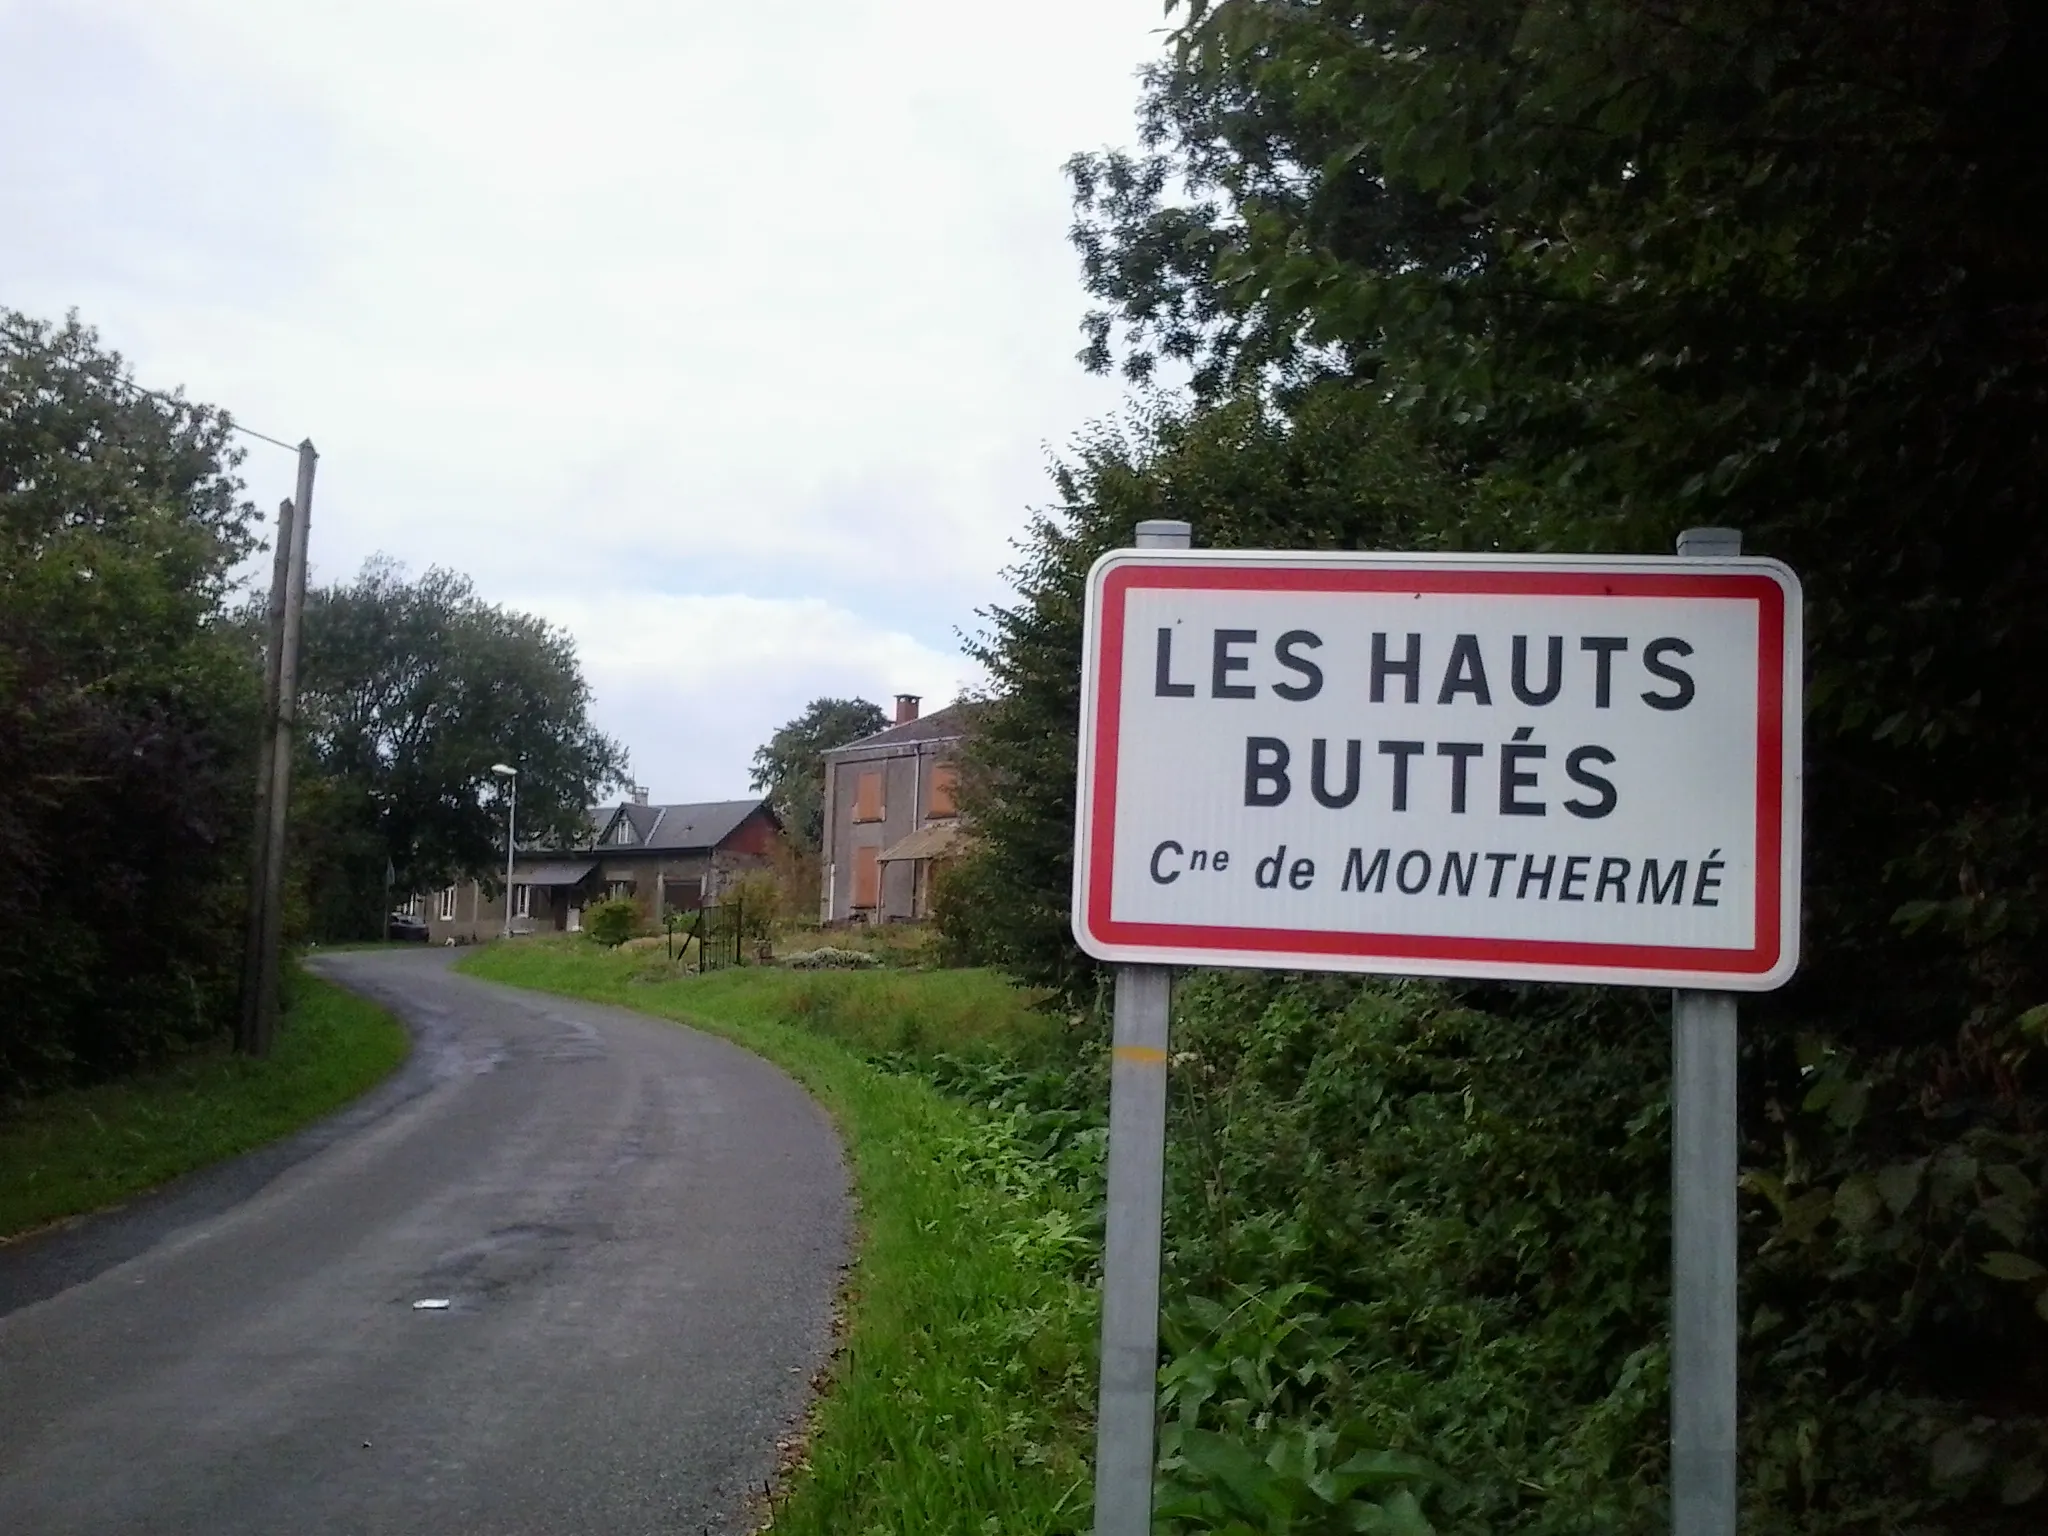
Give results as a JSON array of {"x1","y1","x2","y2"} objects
[{"x1": 299, "y1": 559, "x2": 627, "y2": 938}]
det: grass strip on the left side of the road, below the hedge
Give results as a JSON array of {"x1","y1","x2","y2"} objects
[{"x1": 0, "y1": 971, "x2": 410, "y2": 1237}]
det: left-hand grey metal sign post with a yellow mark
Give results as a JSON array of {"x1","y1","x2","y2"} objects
[{"x1": 1096, "y1": 520, "x2": 1194, "y2": 1536}]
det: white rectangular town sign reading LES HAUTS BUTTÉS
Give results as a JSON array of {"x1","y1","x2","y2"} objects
[{"x1": 1073, "y1": 551, "x2": 1800, "y2": 991}]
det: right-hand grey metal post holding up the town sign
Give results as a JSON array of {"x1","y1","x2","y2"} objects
[{"x1": 1671, "y1": 528, "x2": 1743, "y2": 1536}]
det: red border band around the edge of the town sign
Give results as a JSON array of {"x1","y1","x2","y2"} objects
[{"x1": 1085, "y1": 563, "x2": 1786, "y2": 977}]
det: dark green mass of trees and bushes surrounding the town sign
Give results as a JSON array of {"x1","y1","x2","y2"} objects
[{"x1": 942, "y1": 0, "x2": 2048, "y2": 1536}]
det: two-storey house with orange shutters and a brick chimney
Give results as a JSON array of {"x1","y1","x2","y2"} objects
[{"x1": 819, "y1": 694, "x2": 967, "y2": 924}]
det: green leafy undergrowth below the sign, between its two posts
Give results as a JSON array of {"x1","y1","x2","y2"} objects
[{"x1": 1163, "y1": 973, "x2": 1669, "y2": 1536}]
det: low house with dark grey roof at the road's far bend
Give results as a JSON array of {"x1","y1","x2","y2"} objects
[{"x1": 414, "y1": 788, "x2": 782, "y2": 944}]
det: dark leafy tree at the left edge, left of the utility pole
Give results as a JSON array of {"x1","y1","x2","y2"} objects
[{"x1": 0, "y1": 311, "x2": 258, "y2": 1098}]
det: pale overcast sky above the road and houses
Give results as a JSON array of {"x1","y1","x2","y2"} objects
[{"x1": 0, "y1": 0, "x2": 1163, "y2": 801}]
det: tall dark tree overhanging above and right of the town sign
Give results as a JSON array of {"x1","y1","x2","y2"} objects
[{"x1": 1071, "y1": 0, "x2": 2048, "y2": 1087}]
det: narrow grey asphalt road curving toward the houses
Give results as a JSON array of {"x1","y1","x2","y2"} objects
[{"x1": 0, "y1": 950, "x2": 850, "y2": 1536}]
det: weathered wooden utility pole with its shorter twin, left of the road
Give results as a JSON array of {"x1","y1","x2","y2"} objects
[{"x1": 236, "y1": 440, "x2": 319, "y2": 1057}]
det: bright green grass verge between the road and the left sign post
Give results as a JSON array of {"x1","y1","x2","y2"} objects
[{"x1": 461, "y1": 940, "x2": 1096, "y2": 1536}]
